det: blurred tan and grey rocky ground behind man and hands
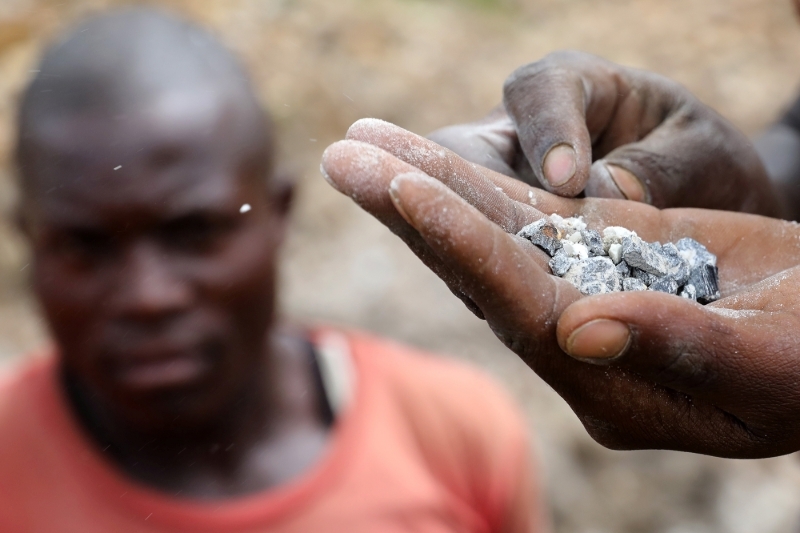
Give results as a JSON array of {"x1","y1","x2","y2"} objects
[{"x1": 0, "y1": 0, "x2": 800, "y2": 533}]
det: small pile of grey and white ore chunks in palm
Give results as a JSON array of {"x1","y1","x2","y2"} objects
[{"x1": 517, "y1": 215, "x2": 720, "y2": 304}]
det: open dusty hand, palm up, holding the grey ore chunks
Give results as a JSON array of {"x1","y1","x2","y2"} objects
[{"x1": 323, "y1": 120, "x2": 800, "y2": 458}]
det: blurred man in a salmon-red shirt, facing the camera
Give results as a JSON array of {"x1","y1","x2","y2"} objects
[{"x1": 0, "y1": 10, "x2": 542, "y2": 533}]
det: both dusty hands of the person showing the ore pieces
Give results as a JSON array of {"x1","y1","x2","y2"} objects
[{"x1": 323, "y1": 46, "x2": 800, "y2": 458}]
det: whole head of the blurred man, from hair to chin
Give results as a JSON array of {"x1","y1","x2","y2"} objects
[{"x1": 17, "y1": 10, "x2": 288, "y2": 425}]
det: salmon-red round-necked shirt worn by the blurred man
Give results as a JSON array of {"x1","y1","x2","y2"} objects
[{"x1": 0, "y1": 328, "x2": 543, "y2": 533}]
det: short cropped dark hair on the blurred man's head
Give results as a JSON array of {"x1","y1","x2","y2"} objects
[{"x1": 15, "y1": 8, "x2": 273, "y2": 191}]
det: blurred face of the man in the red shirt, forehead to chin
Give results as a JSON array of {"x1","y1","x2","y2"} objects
[{"x1": 24, "y1": 98, "x2": 284, "y2": 423}]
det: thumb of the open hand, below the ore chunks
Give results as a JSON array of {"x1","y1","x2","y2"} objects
[{"x1": 556, "y1": 291, "x2": 800, "y2": 420}]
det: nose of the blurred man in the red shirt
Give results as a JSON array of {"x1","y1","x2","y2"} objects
[{"x1": 111, "y1": 243, "x2": 191, "y2": 320}]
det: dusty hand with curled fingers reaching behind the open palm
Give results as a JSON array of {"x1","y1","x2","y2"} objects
[{"x1": 430, "y1": 52, "x2": 779, "y2": 216}]
